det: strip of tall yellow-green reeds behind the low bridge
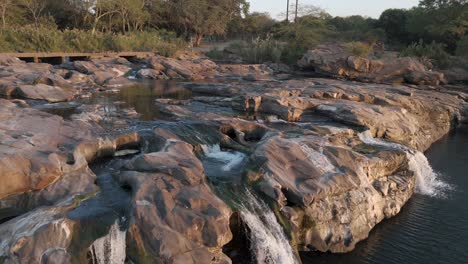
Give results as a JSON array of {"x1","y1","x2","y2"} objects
[{"x1": 0, "y1": 26, "x2": 187, "y2": 56}]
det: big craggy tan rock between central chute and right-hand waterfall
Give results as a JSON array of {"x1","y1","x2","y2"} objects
[{"x1": 253, "y1": 133, "x2": 415, "y2": 252}]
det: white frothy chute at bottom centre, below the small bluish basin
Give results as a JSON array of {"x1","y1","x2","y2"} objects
[{"x1": 239, "y1": 191, "x2": 298, "y2": 264}]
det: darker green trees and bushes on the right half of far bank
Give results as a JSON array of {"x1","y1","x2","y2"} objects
[{"x1": 213, "y1": 0, "x2": 468, "y2": 67}]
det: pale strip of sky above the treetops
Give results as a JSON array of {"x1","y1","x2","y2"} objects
[{"x1": 249, "y1": 0, "x2": 419, "y2": 18}]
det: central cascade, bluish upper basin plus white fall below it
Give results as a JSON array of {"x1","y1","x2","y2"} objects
[{"x1": 202, "y1": 145, "x2": 298, "y2": 264}]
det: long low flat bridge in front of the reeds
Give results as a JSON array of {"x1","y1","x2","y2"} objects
[{"x1": 0, "y1": 52, "x2": 155, "y2": 64}]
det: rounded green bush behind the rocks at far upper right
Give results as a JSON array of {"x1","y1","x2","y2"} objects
[{"x1": 400, "y1": 41, "x2": 450, "y2": 68}]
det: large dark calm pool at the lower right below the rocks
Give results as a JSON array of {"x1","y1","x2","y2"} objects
[{"x1": 301, "y1": 128, "x2": 468, "y2": 264}]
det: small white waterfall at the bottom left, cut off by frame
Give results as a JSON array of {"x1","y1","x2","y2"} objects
[{"x1": 89, "y1": 222, "x2": 127, "y2": 264}]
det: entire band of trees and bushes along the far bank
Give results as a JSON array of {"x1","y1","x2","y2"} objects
[{"x1": 0, "y1": 0, "x2": 468, "y2": 67}]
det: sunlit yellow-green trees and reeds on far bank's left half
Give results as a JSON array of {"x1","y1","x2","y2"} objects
[{"x1": 0, "y1": 0, "x2": 248, "y2": 55}]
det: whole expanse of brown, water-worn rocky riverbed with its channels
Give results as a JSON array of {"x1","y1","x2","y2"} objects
[{"x1": 0, "y1": 49, "x2": 468, "y2": 263}]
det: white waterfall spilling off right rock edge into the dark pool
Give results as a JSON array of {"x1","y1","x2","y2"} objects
[{"x1": 359, "y1": 131, "x2": 450, "y2": 197}]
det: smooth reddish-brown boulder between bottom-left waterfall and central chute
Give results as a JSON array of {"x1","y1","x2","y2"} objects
[{"x1": 116, "y1": 135, "x2": 232, "y2": 264}]
